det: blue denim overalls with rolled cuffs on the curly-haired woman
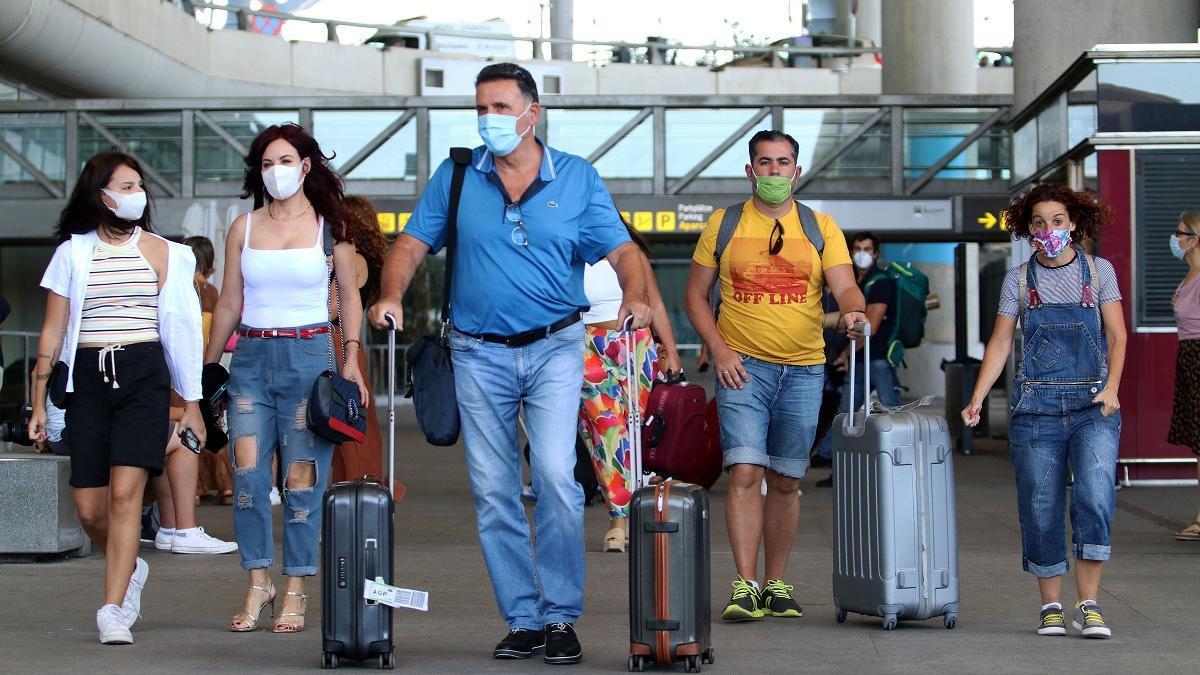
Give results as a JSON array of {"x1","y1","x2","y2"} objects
[{"x1": 1009, "y1": 247, "x2": 1121, "y2": 578}]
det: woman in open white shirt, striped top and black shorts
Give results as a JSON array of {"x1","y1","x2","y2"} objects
[{"x1": 29, "y1": 151, "x2": 204, "y2": 644}]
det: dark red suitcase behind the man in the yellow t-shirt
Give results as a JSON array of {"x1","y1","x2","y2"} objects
[{"x1": 642, "y1": 374, "x2": 721, "y2": 489}]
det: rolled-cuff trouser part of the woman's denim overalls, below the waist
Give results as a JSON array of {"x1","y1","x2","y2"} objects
[{"x1": 1009, "y1": 388, "x2": 1121, "y2": 578}]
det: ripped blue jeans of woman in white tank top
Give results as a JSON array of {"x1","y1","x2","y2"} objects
[{"x1": 228, "y1": 324, "x2": 334, "y2": 577}]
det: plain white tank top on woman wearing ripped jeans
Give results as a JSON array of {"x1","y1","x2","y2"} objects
[{"x1": 241, "y1": 208, "x2": 329, "y2": 328}]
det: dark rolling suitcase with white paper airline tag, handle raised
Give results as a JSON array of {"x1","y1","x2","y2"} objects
[{"x1": 320, "y1": 316, "x2": 405, "y2": 669}]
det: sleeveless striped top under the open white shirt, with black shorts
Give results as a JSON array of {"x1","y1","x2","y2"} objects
[{"x1": 79, "y1": 227, "x2": 158, "y2": 345}]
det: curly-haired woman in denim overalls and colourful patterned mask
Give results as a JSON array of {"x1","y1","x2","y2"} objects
[{"x1": 962, "y1": 185, "x2": 1126, "y2": 638}]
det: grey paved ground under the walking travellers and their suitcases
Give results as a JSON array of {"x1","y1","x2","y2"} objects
[{"x1": 0, "y1": 417, "x2": 1200, "y2": 673}]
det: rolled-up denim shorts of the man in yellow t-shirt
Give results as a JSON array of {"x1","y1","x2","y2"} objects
[{"x1": 716, "y1": 356, "x2": 824, "y2": 478}]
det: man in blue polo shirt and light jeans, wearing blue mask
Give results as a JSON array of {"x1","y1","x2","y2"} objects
[{"x1": 370, "y1": 64, "x2": 650, "y2": 663}]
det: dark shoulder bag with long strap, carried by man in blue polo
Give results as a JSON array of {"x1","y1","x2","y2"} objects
[{"x1": 404, "y1": 148, "x2": 470, "y2": 446}]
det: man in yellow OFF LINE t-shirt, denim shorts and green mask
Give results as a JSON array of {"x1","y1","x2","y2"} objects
[{"x1": 686, "y1": 131, "x2": 866, "y2": 621}]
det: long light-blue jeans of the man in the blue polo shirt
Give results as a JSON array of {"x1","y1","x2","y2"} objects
[{"x1": 450, "y1": 322, "x2": 583, "y2": 631}]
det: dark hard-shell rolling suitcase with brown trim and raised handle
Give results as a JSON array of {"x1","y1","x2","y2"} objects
[{"x1": 626, "y1": 317, "x2": 715, "y2": 673}]
